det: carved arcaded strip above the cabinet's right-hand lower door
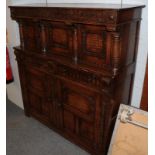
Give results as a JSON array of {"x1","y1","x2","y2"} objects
[{"x1": 48, "y1": 63, "x2": 111, "y2": 91}]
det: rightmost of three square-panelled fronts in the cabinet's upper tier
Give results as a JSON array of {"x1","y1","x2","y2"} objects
[{"x1": 79, "y1": 25, "x2": 108, "y2": 67}]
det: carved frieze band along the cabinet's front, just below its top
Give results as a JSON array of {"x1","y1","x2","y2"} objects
[{"x1": 11, "y1": 8, "x2": 117, "y2": 24}]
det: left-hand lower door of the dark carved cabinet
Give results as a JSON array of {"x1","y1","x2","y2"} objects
[{"x1": 25, "y1": 64, "x2": 52, "y2": 122}]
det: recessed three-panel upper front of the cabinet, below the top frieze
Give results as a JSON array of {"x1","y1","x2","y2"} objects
[{"x1": 19, "y1": 21, "x2": 111, "y2": 65}]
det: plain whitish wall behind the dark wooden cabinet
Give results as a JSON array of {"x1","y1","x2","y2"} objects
[{"x1": 6, "y1": 0, "x2": 148, "y2": 108}]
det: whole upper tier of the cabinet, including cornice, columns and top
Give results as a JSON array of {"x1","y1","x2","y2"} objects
[{"x1": 10, "y1": 4, "x2": 144, "y2": 69}]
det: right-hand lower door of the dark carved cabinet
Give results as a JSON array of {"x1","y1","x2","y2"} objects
[{"x1": 58, "y1": 81, "x2": 101, "y2": 147}]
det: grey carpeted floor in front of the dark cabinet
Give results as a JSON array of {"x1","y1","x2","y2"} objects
[{"x1": 6, "y1": 101, "x2": 89, "y2": 155}]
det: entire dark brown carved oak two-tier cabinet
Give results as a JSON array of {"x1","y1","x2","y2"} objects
[{"x1": 10, "y1": 4, "x2": 144, "y2": 155}]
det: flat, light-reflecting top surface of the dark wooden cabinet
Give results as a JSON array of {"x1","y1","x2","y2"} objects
[{"x1": 9, "y1": 3, "x2": 145, "y2": 10}]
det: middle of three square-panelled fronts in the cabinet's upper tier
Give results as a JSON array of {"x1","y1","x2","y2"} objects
[{"x1": 48, "y1": 22, "x2": 73, "y2": 58}]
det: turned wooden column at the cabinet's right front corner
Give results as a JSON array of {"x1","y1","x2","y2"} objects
[{"x1": 112, "y1": 33, "x2": 121, "y2": 77}]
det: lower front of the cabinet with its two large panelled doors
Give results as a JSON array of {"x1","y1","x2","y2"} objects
[{"x1": 17, "y1": 57, "x2": 111, "y2": 155}]
